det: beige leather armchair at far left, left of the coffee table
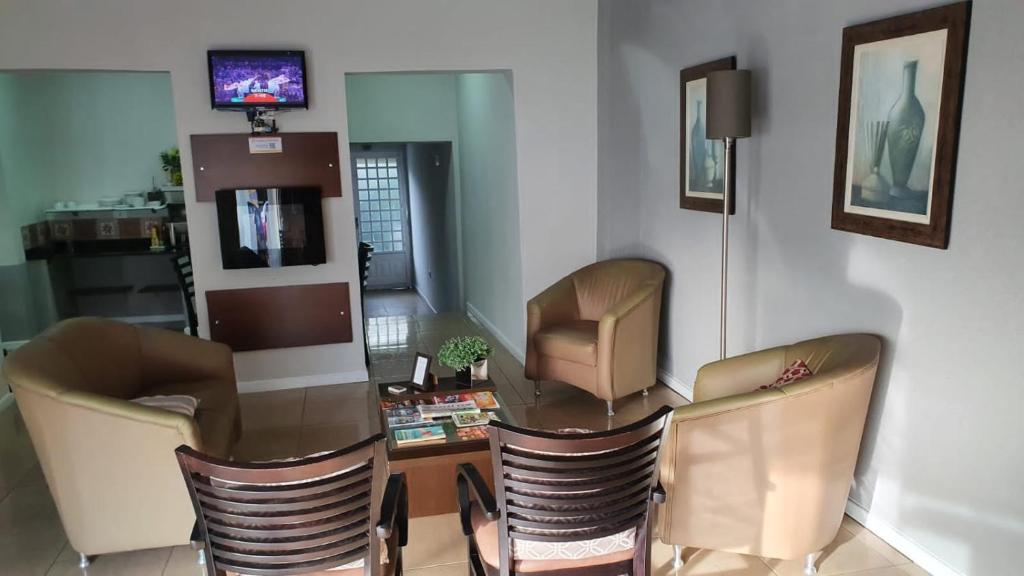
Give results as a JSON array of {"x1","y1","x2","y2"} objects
[{"x1": 3, "y1": 318, "x2": 241, "y2": 564}]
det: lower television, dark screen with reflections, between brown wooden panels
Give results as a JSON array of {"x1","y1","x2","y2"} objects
[{"x1": 216, "y1": 188, "x2": 327, "y2": 270}]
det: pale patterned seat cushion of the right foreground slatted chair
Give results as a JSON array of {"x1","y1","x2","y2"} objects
[{"x1": 472, "y1": 506, "x2": 636, "y2": 573}]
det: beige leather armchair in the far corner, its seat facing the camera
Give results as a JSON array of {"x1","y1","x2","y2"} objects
[{"x1": 525, "y1": 259, "x2": 665, "y2": 416}]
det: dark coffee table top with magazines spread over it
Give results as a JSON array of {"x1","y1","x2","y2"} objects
[{"x1": 372, "y1": 378, "x2": 516, "y2": 461}]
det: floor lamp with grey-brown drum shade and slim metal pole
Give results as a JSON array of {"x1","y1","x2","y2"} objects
[{"x1": 707, "y1": 70, "x2": 751, "y2": 360}]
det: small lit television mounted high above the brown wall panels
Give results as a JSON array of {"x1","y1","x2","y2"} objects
[{"x1": 207, "y1": 50, "x2": 309, "y2": 110}]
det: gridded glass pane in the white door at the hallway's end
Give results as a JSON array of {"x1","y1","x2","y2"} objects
[{"x1": 355, "y1": 157, "x2": 406, "y2": 253}]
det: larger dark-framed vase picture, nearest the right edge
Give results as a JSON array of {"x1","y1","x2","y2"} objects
[{"x1": 831, "y1": 2, "x2": 970, "y2": 249}]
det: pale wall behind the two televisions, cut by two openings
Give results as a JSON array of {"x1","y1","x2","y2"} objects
[{"x1": 0, "y1": 0, "x2": 597, "y2": 380}]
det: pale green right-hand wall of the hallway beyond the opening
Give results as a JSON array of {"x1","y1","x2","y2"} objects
[{"x1": 457, "y1": 73, "x2": 528, "y2": 358}]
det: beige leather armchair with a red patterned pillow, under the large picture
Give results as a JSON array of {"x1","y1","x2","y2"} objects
[{"x1": 659, "y1": 334, "x2": 881, "y2": 574}]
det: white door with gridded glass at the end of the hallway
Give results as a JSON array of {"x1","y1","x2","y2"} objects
[{"x1": 351, "y1": 145, "x2": 412, "y2": 289}]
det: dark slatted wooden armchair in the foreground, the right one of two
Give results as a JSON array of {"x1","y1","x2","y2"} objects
[{"x1": 456, "y1": 407, "x2": 672, "y2": 576}]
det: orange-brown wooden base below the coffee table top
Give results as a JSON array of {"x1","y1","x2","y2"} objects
[{"x1": 390, "y1": 450, "x2": 495, "y2": 518}]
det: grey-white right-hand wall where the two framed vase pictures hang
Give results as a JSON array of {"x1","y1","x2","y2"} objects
[{"x1": 598, "y1": 0, "x2": 1024, "y2": 576}]
